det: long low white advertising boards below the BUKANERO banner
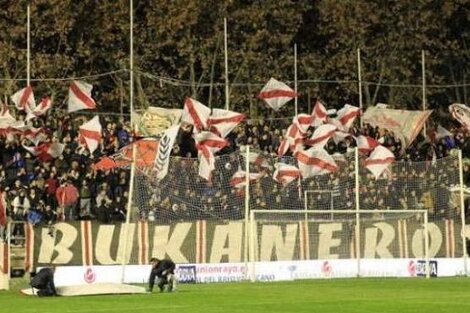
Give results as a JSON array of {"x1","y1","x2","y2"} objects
[{"x1": 51, "y1": 258, "x2": 466, "y2": 286}]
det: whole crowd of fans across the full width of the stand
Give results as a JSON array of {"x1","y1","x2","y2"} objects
[{"x1": 0, "y1": 111, "x2": 470, "y2": 235}]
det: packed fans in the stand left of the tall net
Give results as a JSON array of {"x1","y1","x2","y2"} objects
[{"x1": 0, "y1": 111, "x2": 132, "y2": 240}]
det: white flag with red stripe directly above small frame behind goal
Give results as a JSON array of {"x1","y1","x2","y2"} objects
[{"x1": 296, "y1": 148, "x2": 339, "y2": 178}]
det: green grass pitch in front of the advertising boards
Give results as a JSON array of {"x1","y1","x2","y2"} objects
[{"x1": 0, "y1": 278, "x2": 470, "y2": 313}]
